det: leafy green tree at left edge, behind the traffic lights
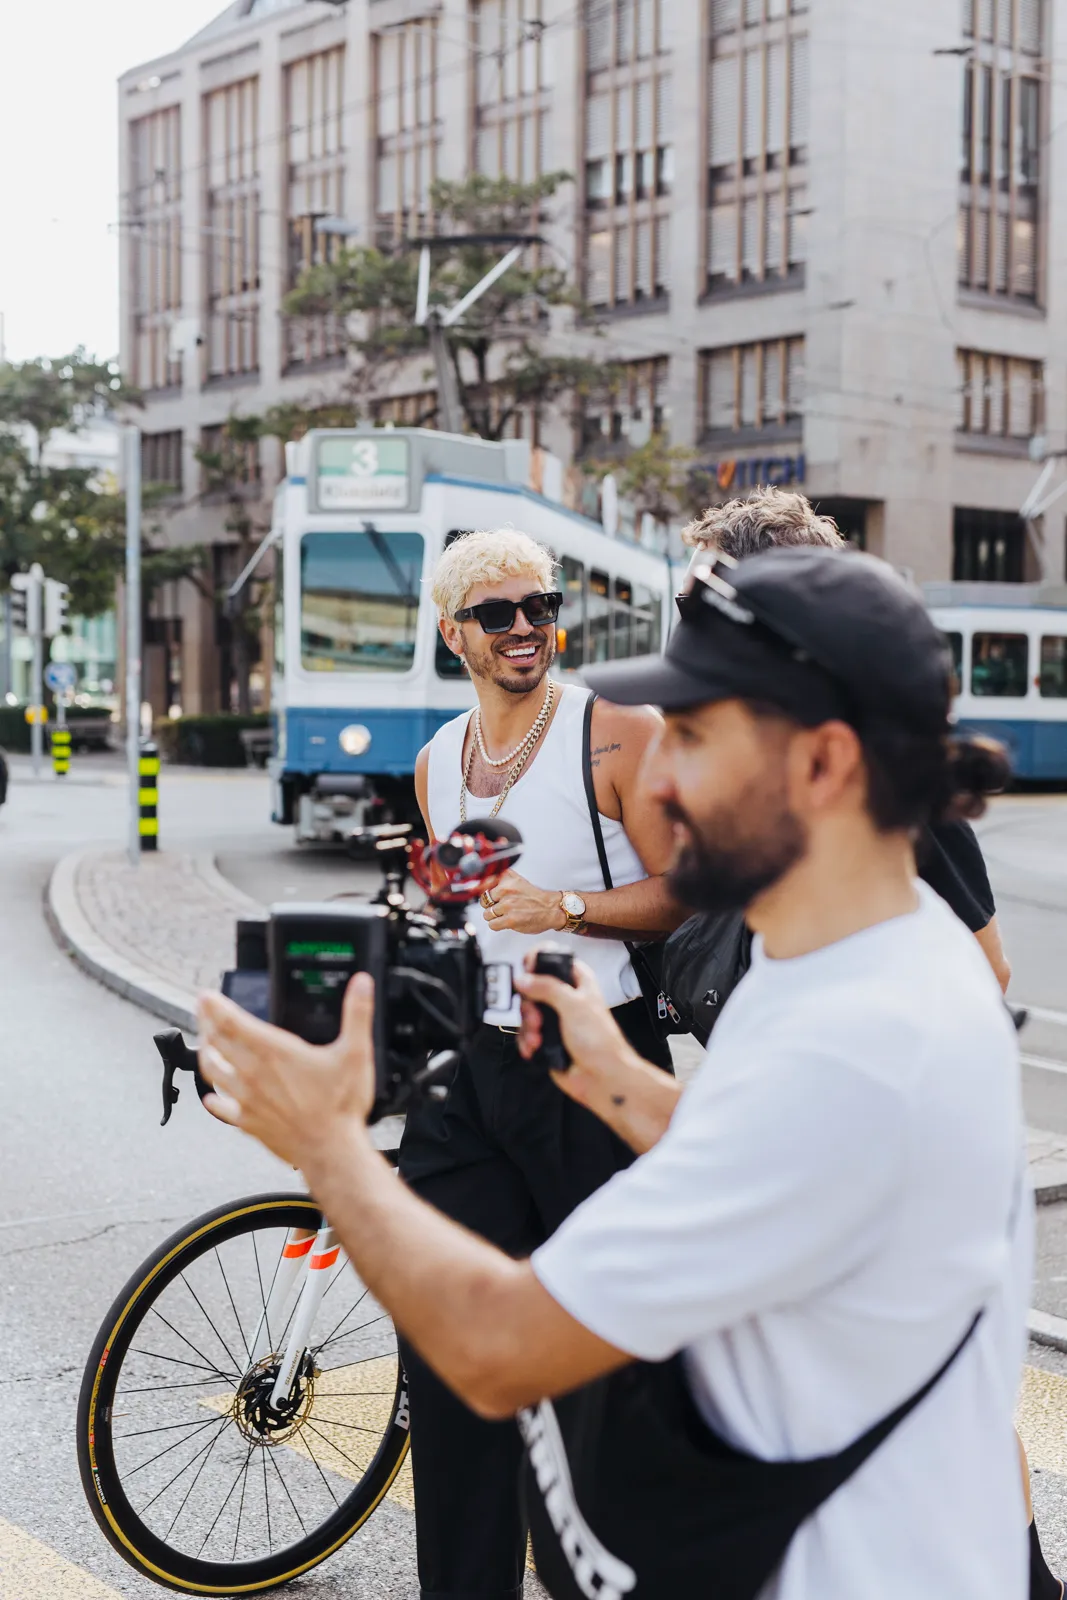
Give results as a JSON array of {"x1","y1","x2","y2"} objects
[{"x1": 0, "y1": 349, "x2": 138, "y2": 616}]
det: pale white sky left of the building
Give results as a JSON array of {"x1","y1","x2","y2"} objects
[{"x1": 0, "y1": 0, "x2": 226, "y2": 362}]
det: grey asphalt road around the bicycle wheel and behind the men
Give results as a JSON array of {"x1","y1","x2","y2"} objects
[{"x1": 0, "y1": 758, "x2": 1067, "y2": 1600}]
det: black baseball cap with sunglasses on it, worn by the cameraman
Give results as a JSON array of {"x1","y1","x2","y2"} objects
[{"x1": 585, "y1": 546, "x2": 952, "y2": 733}]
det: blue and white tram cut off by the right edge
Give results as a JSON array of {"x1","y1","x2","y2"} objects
[{"x1": 931, "y1": 598, "x2": 1067, "y2": 779}]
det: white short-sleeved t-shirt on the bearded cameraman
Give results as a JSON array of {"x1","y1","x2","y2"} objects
[{"x1": 533, "y1": 885, "x2": 1032, "y2": 1600}]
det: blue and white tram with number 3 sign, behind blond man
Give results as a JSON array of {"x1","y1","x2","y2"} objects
[{"x1": 270, "y1": 427, "x2": 673, "y2": 842}]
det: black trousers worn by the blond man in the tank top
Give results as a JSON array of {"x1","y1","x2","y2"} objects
[{"x1": 400, "y1": 1000, "x2": 670, "y2": 1600}]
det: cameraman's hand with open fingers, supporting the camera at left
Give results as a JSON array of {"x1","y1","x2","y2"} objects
[{"x1": 198, "y1": 973, "x2": 374, "y2": 1170}]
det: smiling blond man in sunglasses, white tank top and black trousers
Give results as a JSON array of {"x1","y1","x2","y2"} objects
[{"x1": 400, "y1": 528, "x2": 685, "y2": 1600}]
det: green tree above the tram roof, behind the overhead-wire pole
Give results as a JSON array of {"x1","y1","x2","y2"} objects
[{"x1": 285, "y1": 173, "x2": 611, "y2": 438}]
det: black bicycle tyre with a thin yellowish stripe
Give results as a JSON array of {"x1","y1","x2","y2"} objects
[{"x1": 77, "y1": 1194, "x2": 408, "y2": 1595}]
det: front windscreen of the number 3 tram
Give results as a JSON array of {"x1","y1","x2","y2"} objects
[{"x1": 301, "y1": 528, "x2": 424, "y2": 672}]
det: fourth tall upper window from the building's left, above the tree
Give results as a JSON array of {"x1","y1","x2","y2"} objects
[{"x1": 374, "y1": 19, "x2": 442, "y2": 245}]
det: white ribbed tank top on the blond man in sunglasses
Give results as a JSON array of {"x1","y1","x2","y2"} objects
[{"x1": 427, "y1": 683, "x2": 648, "y2": 1027}]
